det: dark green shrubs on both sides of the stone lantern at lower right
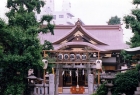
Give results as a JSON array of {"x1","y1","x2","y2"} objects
[{"x1": 93, "y1": 65, "x2": 140, "y2": 95}]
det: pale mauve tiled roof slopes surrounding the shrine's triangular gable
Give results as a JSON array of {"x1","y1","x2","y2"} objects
[{"x1": 39, "y1": 25, "x2": 129, "y2": 51}]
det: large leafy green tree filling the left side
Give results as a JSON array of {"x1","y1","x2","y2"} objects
[{"x1": 0, "y1": 0, "x2": 54, "y2": 95}]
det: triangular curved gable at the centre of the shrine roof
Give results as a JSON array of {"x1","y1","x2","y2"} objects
[{"x1": 53, "y1": 24, "x2": 107, "y2": 45}]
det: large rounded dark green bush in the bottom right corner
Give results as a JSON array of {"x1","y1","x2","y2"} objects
[{"x1": 114, "y1": 69, "x2": 139, "y2": 95}]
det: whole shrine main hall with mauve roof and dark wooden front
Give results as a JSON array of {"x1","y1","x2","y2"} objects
[{"x1": 39, "y1": 20, "x2": 128, "y2": 92}]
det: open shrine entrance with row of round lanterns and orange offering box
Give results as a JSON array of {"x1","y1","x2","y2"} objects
[{"x1": 44, "y1": 50, "x2": 101, "y2": 95}]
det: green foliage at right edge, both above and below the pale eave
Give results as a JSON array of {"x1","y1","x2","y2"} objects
[{"x1": 122, "y1": 0, "x2": 140, "y2": 67}]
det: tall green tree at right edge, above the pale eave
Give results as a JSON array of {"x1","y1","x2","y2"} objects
[{"x1": 124, "y1": 0, "x2": 140, "y2": 47}]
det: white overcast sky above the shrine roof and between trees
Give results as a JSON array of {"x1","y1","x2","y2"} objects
[{"x1": 0, "y1": 0, "x2": 135, "y2": 42}]
